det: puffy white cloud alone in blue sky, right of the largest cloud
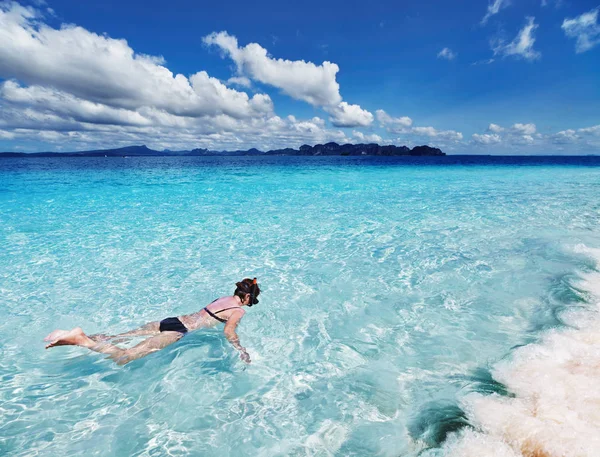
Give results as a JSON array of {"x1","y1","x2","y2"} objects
[{"x1": 203, "y1": 32, "x2": 342, "y2": 106}]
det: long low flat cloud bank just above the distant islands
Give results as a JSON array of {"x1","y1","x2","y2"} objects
[{"x1": 0, "y1": 104, "x2": 356, "y2": 150}]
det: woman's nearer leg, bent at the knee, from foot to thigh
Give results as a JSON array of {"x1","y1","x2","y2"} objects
[{"x1": 44, "y1": 327, "x2": 183, "y2": 365}]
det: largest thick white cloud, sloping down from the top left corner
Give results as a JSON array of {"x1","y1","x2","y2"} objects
[{"x1": 0, "y1": 3, "x2": 272, "y2": 117}]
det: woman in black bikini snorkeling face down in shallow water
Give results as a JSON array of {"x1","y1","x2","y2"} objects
[{"x1": 44, "y1": 278, "x2": 260, "y2": 365}]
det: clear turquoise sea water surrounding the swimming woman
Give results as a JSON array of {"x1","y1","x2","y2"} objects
[{"x1": 0, "y1": 157, "x2": 600, "y2": 456}]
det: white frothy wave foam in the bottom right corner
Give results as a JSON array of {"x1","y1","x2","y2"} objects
[{"x1": 444, "y1": 245, "x2": 600, "y2": 457}]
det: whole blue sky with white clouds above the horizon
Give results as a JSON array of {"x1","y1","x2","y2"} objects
[{"x1": 0, "y1": 0, "x2": 600, "y2": 155}]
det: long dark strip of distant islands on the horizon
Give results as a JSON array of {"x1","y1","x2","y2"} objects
[{"x1": 0, "y1": 142, "x2": 446, "y2": 157}]
